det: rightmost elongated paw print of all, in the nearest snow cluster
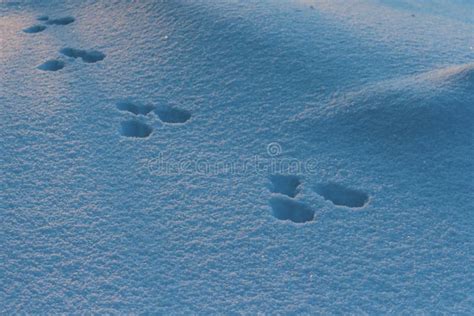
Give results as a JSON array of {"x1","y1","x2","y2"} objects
[{"x1": 315, "y1": 183, "x2": 369, "y2": 208}]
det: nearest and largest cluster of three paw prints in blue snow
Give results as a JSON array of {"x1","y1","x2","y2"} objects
[{"x1": 270, "y1": 175, "x2": 369, "y2": 223}]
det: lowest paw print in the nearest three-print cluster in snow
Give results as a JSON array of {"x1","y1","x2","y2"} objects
[{"x1": 270, "y1": 196, "x2": 314, "y2": 223}]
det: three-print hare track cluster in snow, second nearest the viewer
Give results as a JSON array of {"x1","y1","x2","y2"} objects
[{"x1": 116, "y1": 101, "x2": 191, "y2": 138}]
